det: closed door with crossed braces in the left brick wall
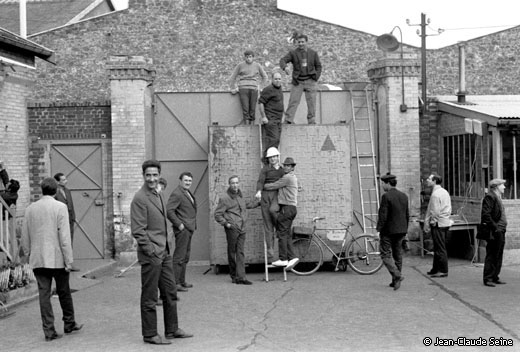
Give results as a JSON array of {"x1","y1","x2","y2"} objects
[{"x1": 50, "y1": 142, "x2": 105, "y2": 259}]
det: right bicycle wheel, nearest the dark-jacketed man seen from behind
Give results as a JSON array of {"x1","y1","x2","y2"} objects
[{"x1": 347, "y1": 235, "x2": 383, "y2": 275}]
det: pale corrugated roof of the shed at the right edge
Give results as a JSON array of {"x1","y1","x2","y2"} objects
[{"x1": 436, "y1": 95, "x2": 520, "y2": 120}]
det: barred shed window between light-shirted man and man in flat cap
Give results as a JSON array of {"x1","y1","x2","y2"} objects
[{"x1": 443, "y1": 134, "x2": 491, "y2": 198}]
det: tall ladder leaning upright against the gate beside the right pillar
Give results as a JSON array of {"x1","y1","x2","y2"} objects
[{"x1": 349, "y1": 88, "x2": 379, "y2": 233}]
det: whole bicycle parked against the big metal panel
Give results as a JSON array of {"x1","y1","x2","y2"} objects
[{"x1": 291, "y1": 217, "x2": 383, "y2": 275}]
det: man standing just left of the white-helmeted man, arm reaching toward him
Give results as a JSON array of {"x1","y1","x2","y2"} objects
[{"x1": 215, "y1": 175, "x2": 258, "y2": 285}]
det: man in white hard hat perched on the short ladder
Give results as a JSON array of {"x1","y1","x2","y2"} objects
[{"x1": 255, "y1": 147, "x2": 285, "y2": 263}]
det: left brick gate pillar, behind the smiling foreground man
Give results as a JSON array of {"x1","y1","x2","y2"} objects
[{"x1": 108, "y1": 56, "x2": 155, "y2": 257}]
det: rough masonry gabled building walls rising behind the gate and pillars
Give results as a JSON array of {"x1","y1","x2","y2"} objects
[{"x1": 25, "y1": 0, "x2": 520, "y2": 101}]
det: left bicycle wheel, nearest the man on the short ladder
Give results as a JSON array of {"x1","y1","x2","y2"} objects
[{"x1": 291, "y1": 238, "x2": 323, "y2": 275}]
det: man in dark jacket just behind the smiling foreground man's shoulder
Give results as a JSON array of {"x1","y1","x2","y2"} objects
[{"x1": 166, "y1": 172, "x2": 197, "y2": 292}]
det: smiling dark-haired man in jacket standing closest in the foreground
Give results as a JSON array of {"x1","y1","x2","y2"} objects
[{"x1": 130, "y1": 160, "x2": 193, "y2": 345}]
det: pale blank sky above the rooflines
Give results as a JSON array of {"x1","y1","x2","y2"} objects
[{"x1": 278, "y1": 0, "x2": 520, "y2": 49}]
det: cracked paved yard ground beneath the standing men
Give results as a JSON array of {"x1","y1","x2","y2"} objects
[{"x1": 0, "y1": 257, "x2": 520, "y2": 352}]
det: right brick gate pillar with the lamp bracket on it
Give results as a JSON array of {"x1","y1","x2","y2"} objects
[{"x1": 368, "y1": 51, "x2": 421, "y2": 216}]
